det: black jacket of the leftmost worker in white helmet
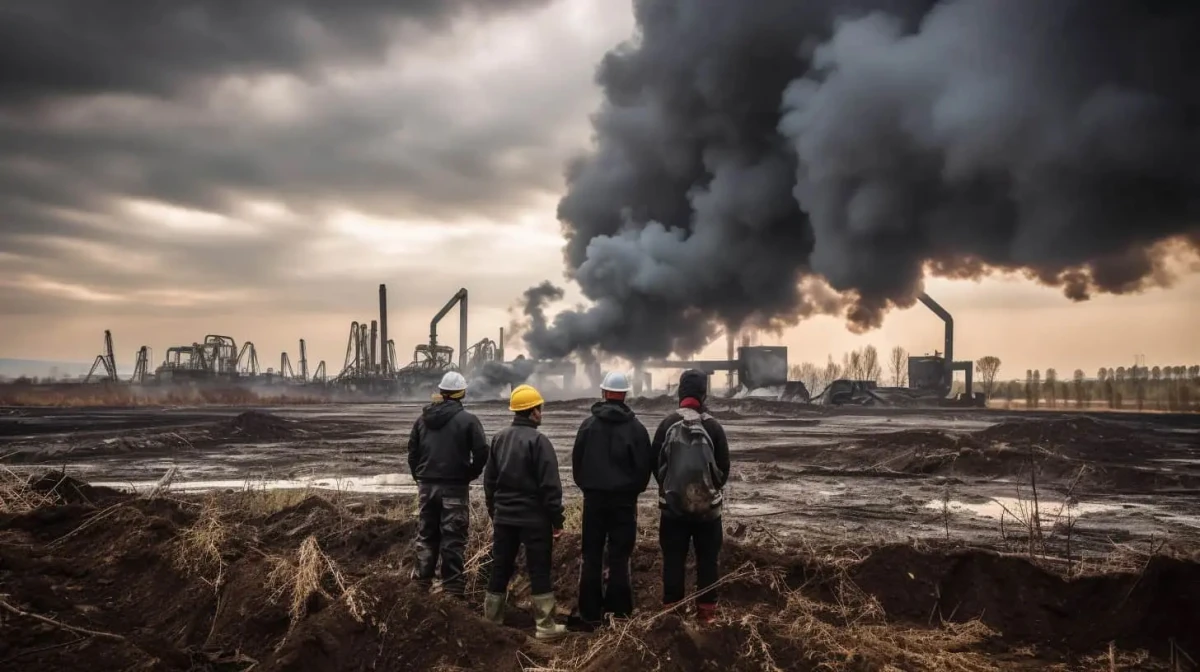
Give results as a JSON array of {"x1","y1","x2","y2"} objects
[{"x1": 408, "y1": 400, "x2": 487, "y2": 485}]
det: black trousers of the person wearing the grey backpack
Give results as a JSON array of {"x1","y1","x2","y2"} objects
[{"x1": 659, "y1": 516, "x2": 725, "y2": 605}]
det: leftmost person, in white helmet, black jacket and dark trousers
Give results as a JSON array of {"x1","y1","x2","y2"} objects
[{"x1": 408, "y1": 371, "x2": 487, "y2": 598}]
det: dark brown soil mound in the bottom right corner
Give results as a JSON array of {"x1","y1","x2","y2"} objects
[{"x1": 850, "y1": 546, "x2": 1200, "y2": 652}]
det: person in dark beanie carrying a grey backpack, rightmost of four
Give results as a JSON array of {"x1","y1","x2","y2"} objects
[{"x1": 653, "y1": 368, "x2": 730, "y2": 623}]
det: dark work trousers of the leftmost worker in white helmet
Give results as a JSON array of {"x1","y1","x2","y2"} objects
[{"x1": 413, "y1": 484, "x2": 470, "y2": 596}]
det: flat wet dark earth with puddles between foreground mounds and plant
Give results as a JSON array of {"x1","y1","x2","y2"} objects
[{"x1": 0, "y1": 398, "x2": 1200, "y2": 560}]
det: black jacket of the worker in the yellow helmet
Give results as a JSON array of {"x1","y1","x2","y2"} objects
[{"x1": 484, "y1": 416, "x2": 563, "y2": 529}]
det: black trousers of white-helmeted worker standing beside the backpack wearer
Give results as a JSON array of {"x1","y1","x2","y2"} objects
[{"x1": 578, "y1": 496, "x2": 637, "y2": 623}]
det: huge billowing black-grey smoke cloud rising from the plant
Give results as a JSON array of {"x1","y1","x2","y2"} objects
[{"x1": 524, "y1": 0, "x2": 1200, "y2": 359}]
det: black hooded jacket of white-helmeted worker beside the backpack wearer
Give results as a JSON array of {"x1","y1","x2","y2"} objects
[{"x1": 571, "y1": 401, "x2": 655, "y2": 500}]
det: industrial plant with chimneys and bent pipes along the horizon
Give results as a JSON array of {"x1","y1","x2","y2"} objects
[{"x1": 32, "y1": 284, "x2": 984, "y2": 406}]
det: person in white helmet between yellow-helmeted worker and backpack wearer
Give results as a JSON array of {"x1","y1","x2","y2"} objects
[{"x1": 570, "y1": 371, "x2": 654, "y2": 630}]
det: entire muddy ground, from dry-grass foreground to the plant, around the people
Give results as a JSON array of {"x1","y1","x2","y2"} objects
[{"x1": 0, "y1": 400, "x2": 1200, "y2": 672}]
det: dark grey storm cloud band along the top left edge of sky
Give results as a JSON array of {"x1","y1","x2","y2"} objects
[{"x1": 0, "y1": 0, "x2": 541, "y2": 103}]
